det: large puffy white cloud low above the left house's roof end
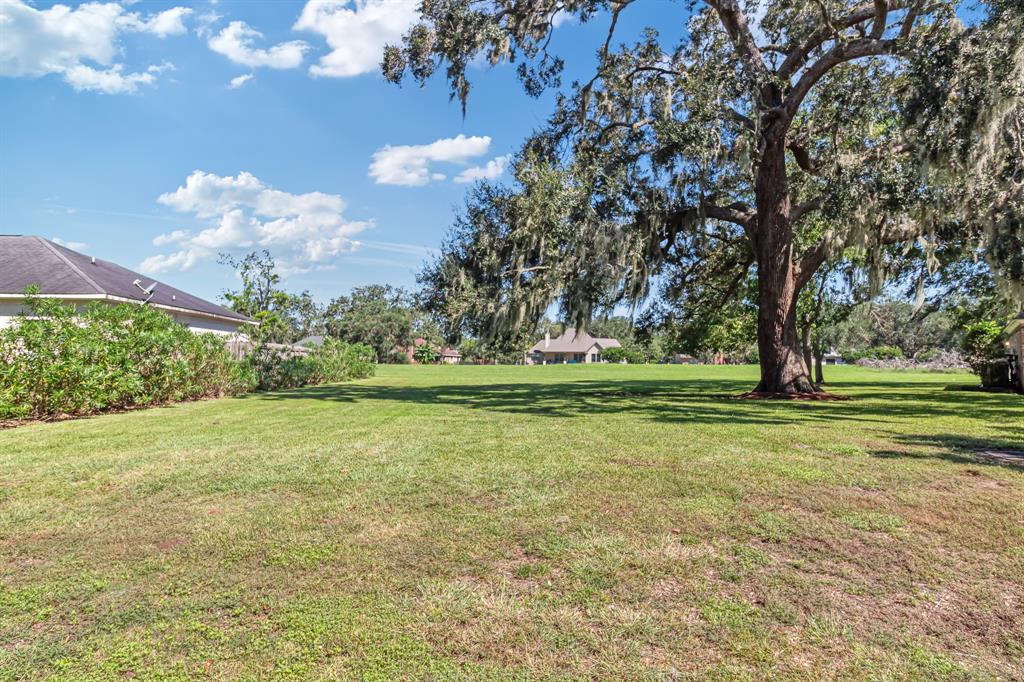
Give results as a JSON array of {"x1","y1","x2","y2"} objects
[{"x1": 139, "y1": 171, "x2": 373, "y2": 274}]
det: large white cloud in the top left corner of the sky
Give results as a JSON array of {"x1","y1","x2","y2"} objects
[{"x1": 0, "y1": 0, "x2": 191, "y2": 93}]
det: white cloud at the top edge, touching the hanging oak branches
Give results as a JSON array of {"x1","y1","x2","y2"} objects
[{"x1": 293, "y1": 0, "x2": 420, "y2": 78}]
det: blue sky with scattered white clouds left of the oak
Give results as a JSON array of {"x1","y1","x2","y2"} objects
[{"x1": 0, "y1": 0, "x2": 681, "y2": 300}]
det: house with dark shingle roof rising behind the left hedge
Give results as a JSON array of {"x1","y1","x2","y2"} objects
[{"x1": 0, "y1": 235, "x2": 256, "y2": 335}]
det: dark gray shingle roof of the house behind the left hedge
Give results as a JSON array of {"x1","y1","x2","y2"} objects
[{"x1": 0, "y1": 235, "x2": 251, "y2": 322}]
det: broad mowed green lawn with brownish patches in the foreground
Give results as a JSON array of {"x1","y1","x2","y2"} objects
[{"x1": 0, "y1": 366, "x2": 1024, "y2": 680}]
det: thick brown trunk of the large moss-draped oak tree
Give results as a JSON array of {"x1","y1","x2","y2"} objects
[{"x1": 753, "y1": 133, "x2": 819, "y2": 394}]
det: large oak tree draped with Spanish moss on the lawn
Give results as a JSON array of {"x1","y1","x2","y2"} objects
[{"x1": 383, "y1": 0, "x2": 1024, "y2": 394}]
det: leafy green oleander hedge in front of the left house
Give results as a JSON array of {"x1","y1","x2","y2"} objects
[{"x1": 0, "y1": 292, "x2": 251, "y2": 419}]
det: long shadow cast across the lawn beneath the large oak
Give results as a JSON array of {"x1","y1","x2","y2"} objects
[{"x1": 243, "y1": 378, "x2": 1024, "y2": 425}]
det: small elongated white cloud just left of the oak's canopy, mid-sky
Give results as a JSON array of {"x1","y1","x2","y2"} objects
[{"x1": 370, "y1": 135, "x2": 490, "y2": 187}]
